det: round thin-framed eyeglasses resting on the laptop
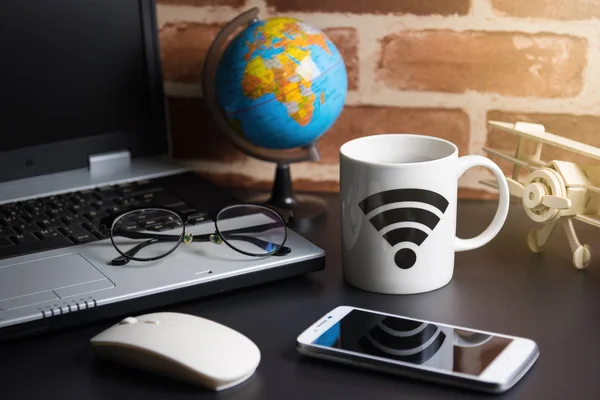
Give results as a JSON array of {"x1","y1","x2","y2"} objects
[{"x1": 100, "y1": 204, "x2": 291, "y2": 265}]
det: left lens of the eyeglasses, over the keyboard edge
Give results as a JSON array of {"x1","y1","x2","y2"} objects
[{"x1": 111, "y1": 208, "x2": 183, "y2": 261}]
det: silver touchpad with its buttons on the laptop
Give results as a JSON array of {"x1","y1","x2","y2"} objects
[{"x1": 0, "y1": 254, "x2": 114, "y2": 310}]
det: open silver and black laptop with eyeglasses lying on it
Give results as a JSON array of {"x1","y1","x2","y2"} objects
[{"x1": 0, "y1": 0, "x2": 325, "y2": 339}]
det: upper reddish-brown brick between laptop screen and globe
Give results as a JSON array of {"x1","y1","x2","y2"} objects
[{"x1": 159, "y1": 22, "x2": 221, "y2": 84}]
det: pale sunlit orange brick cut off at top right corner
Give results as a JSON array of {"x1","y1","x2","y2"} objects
[{"x1": 492, "y1": 0, "x2": 600, "y2": 20}]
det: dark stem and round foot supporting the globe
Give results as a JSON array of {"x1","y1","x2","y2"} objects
[{"x1": 248, "y1": 164, "x2": 327, "y2": 230}]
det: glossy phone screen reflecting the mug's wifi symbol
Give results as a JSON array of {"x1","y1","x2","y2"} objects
[{"x1": 313, "y1": 310, "x2": 513, "y2": 376}]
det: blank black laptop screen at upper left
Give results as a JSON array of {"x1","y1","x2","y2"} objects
[{"x1": 0, "y1": 0, "x2": 167, "y2": 180}]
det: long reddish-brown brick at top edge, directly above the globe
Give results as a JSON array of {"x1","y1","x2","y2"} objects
[{"x1": 267, "y1": 0, "x2": 471, "y2": 15}]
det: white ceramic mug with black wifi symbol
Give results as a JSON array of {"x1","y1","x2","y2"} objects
[{"x1": 340, "y1": 134, "x2": 510, "y2": 294}]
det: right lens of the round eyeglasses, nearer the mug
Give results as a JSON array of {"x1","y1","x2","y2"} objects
[{"x1": 216, "y1": 204, "x2": 287, "y2": 256}]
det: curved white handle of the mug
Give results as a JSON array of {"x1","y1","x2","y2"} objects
[{"x1": 454, "y1": 155, "x2": 510, "y2": 251}]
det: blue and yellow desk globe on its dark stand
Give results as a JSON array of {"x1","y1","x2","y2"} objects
[{"x1": 202, "y1": 8, "x2": 348, "y2": 228}]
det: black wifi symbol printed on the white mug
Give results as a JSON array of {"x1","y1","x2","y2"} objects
[{"x1": 358, "y1": 189, "x2": 448, "y2": 269}]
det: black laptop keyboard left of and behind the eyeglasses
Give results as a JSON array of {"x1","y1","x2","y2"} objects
[{"x1": 0, "y1": 180, "x2": 197, "y2": 259}]
